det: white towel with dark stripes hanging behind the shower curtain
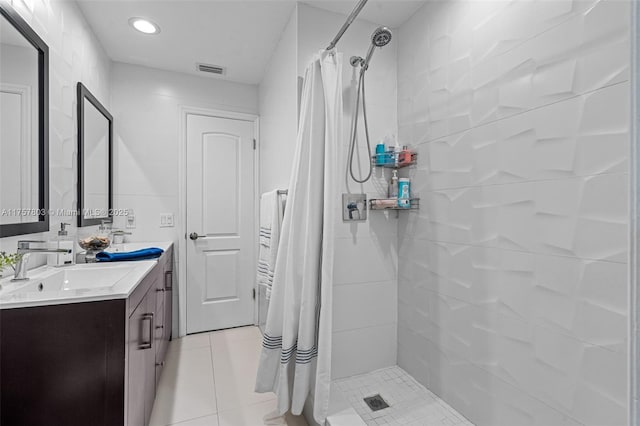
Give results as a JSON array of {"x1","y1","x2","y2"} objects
[{"x1": 256, "y1": 190, "x2": 282, "y2": 300}]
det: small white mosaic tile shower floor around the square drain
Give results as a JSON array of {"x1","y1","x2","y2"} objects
[{"x1": 334, "y1": 366, "x2": 473, "y2": 426}]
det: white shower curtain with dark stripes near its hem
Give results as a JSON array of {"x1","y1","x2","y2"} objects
[{"x1": 256, "y1": 51, "x2": 342, "y2": 424}]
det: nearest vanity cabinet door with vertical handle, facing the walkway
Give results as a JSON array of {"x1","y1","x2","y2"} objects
[{"x1": 127, "y1": 298, "x2": 153, "y2": 426}]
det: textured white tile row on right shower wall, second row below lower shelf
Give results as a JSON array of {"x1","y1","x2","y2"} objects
[{"x1": 398, "y1": 241, "x2": 627, "y2": 349}]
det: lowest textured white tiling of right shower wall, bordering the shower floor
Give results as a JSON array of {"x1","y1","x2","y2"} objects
[{"x1": 398, "y1": 312, "x2": 626, "y2": 425}]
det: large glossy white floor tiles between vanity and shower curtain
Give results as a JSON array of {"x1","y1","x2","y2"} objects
[{"x1": 150, "y1": 327, "x2": 307, "y2": 426}]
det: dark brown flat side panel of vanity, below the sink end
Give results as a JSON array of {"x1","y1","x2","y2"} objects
[{"x1": 0, "y1": 299, "x2": 125, "y2": 426}]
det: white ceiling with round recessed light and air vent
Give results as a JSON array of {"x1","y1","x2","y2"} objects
[{"x1": 78, "y1": 0, "x2": 424, "y2": 84}]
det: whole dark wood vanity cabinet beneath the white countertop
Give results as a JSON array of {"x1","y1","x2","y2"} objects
[{"x1": 0, "y1": 249, "x2": 173, "y2": 426}]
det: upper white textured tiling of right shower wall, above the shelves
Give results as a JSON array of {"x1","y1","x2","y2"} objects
[{"x1": 398, "y1": 0, "x2": 630, "y2": 143}]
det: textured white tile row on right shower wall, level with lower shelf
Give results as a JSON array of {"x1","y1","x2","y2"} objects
[{"x1": 412, "y1": 173, "x2": 629, "y2": 262}]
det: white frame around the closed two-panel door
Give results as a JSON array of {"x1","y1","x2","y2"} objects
[{"x1": 174, "y1": 105, "x2": 260, "y2": 337}]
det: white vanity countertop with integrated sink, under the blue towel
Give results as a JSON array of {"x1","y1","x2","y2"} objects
[{"x1": 0, "y1": 241, "x2": 173, "y2": 309}]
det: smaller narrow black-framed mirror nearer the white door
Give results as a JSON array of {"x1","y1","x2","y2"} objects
[{"x1": 78, "y1": 83, "x2": 113, "y2": 227}]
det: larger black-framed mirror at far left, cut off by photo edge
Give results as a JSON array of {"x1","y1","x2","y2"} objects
[{"x1": 0, "y1": 2, "x2": 49, "y2": 238}]
